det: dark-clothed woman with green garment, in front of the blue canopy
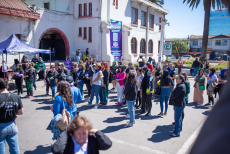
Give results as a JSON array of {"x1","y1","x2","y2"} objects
[{"x1": 25, "y1": 64, "x2": 34, "y2": 98}]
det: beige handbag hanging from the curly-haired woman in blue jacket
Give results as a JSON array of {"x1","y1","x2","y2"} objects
[{"x1": 57, "y1": 101, "x2": 71, "y2": 130}]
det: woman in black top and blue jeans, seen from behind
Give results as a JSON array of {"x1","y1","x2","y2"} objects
[{"x1": 158, "y1": 70, "x2": 172, "y2": 117}]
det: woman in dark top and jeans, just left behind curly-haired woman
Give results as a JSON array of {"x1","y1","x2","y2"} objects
[{"x1": 47, "y1": 65, "x2": 58, "y2": 101}]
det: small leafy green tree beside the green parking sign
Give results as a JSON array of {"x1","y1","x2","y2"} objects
[{"x1": 172, "y1": 40, "x2": 190, "y2": 58}]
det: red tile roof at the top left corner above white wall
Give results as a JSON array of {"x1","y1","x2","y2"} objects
[{"x1": 0, "y1": 0, "x2": 40, "y2": 19}]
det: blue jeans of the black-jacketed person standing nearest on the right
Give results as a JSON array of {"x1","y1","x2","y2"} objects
[{"x1": 174, "y1": 106, "x2": 185, "y2": 136}]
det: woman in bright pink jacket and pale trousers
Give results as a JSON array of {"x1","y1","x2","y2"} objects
[{"x1": 115, "y1": 65, "x2": 126, "y2": 106}]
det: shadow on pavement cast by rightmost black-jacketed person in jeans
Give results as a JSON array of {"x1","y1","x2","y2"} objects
[{"x1": 148, "y1": 124, "x2": 173, "y2": 142}]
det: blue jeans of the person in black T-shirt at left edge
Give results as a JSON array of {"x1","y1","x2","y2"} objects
[{"x1": 0, "y1": 121, "x2": 20, "y2": 154}]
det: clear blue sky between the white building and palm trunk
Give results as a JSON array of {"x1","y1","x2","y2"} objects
[{"x1": 163, "y1": 0, "x2": 204, "y2": 38}]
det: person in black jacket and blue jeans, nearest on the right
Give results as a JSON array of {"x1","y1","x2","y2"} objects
[{"x1": 170, "y1": 75, "x2": 186, "y2": 137}]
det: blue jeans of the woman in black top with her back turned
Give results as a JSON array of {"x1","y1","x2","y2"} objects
[{"x1": 160, "y1": 88, "x2": 170, "y2": 112}]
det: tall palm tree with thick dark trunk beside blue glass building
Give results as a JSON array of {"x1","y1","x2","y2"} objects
[{"x1": 183, "y1": 0, "x2": 222, "y2": 62}]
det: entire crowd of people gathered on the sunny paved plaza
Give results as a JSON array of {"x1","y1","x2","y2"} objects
[{"x1": 0, "y1": 55, "x2": 228, "y2": 153}]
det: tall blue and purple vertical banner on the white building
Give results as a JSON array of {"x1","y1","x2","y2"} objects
[{"x1": 110, "y1": 19, "x2": 122, "y2": 61}]
